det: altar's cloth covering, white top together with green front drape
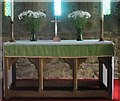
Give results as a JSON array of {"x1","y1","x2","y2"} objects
[{"x1": 4, "y1": 40, "x2": 114, "y2": 58}]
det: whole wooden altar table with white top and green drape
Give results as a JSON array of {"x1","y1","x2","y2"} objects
[{"x1": 3, "y1": 40, "x2": 114, "y2": 99}]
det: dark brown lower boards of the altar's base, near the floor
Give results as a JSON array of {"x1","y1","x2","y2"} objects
[{"x1": 5, "y1": 79, "x2": 108, "y2": 98}]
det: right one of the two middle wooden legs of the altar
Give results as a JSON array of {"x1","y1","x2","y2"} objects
[{"x1": 73, "y1": 58, "x2": 78, "y2": 92}]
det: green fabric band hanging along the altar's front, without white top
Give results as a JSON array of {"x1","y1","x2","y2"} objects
[{"x1": 4, "y1": 44, "x2": 114, "y2": 57}]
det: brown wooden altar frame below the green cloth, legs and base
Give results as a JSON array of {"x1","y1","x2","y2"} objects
[{"x1": 3, "y1": 57, "x2": 113, "y2": 99}]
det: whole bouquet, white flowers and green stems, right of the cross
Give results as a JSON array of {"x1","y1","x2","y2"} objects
[{"x1": 68, "y1": 10, "x2": 91, "y2": 40}]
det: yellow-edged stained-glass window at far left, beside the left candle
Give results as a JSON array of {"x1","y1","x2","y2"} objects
[{"x1": 4, "y1": 0, "x2": 11, "y2": 16}]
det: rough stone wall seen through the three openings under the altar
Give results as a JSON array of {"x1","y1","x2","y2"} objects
[{"x1": 16, "y1": 58, "x2": 99, "y2": 79}]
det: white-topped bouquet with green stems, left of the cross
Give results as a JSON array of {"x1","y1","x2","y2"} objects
[{"x1": 18, "y1": 10, "x2": 46, "y2": 40}]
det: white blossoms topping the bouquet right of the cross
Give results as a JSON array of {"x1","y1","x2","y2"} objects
[{"x1": 68, "y1": 10, "x2": 91, "y2": 19}]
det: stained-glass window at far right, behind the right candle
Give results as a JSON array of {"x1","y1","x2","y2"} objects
[{"x1": 103, "y1": 0, "x2": 111, "y2": 15}]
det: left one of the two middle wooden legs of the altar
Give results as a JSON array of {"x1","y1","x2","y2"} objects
[{"x1": 38, "y1": 58, "x2": 44, "y2": 92}]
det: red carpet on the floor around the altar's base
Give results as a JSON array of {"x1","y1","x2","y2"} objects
[{"x1": 0, "y1": 80, "x2": 120, "y2": 101}]
